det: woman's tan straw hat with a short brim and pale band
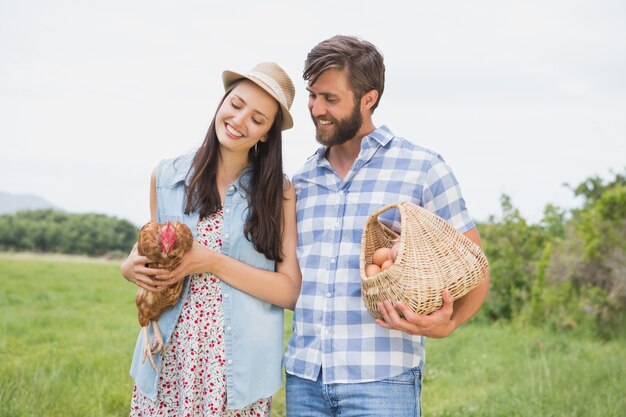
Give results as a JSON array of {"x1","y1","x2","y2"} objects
[{"x1": 222, "y1": 62, "x2": 296, "y2": 130}]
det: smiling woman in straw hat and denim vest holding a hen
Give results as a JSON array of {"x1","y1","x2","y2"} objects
[{"x1": 122, "y1": 63, "x2": 301, "y2": 416}]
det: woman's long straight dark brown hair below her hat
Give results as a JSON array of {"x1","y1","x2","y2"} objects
[{"x1": 185, "y1": 83, "x2": 286, "y2": 262}]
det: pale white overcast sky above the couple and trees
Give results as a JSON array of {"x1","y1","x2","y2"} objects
[{"x1": 0, "y1": 0, "x2": 626, "y2": 225}]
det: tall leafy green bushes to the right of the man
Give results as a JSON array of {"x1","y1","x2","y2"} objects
[{"x1": 479, "y1": 168, "x2": 626, "y2": 338}]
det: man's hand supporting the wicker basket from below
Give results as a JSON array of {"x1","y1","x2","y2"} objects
[{"x1": 376, "y1": 290, "x2": 456, "y2": 338}]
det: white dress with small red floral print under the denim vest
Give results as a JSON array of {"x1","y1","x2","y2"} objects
[{"x1": 130, "y1": 210, "x2": 271, "y2": 417}]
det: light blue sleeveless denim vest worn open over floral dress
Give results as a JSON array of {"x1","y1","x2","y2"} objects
[{"x1": 130, "y1": 154, "x2": 283, "y2": 409}]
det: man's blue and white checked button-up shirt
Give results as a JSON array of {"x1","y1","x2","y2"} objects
[{"x1": 285, "y1": 126, "x2": 474, "y2": 384}]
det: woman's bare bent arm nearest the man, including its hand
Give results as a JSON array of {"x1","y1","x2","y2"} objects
[{"x1": 156, "y1": 185, "x2": 302, "y2": 310}]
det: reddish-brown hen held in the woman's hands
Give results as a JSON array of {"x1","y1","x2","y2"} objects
[{"x1": 135, "y1": 222, "x2": 193, "y2": 371}]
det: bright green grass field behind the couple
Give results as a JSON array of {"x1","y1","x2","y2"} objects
[{"x1": 0, "y1": 254, "x2": 626, "y2": 417}]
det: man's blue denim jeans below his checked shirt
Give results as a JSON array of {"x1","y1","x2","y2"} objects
[{"x1": 286, "y1": 362, "x2": 423, "y2": 417}]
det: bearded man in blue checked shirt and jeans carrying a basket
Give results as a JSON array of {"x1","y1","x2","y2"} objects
[{"x1": 285, "y1": 36, "x2": 489, "y2": 417}]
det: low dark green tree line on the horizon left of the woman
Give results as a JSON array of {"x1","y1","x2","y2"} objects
[{"x1": 0, "y1": 209, "x2": 138, "y2": 256}]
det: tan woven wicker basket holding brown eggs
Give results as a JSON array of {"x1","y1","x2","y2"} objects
[{"x1": 360, "y1": 201, "x2": 489, "y2": 318}]
